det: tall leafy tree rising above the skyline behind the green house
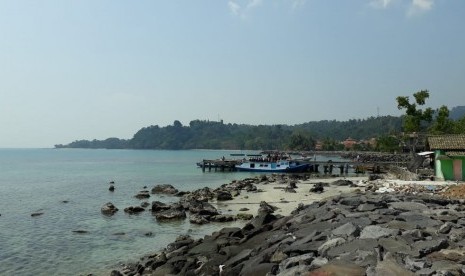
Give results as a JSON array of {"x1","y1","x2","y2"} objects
[{"x1": 396, "y1": 90, "x2": 433, "y2": 132}]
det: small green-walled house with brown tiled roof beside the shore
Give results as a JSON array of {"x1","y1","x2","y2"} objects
[{"x1": 427, "y1": 134, "x2": 465, "y2": 180}]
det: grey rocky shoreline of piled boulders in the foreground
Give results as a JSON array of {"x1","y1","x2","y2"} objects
[{"x1": 110, "y1": 176, "x2": 465, "y2": 276}]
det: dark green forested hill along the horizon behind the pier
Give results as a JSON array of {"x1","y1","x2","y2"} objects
[{"x1": 55, "y1": 116, "x2": 402, "y2": 150}]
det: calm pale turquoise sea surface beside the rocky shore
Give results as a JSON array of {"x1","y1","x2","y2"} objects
[{"x1": 0, "y1": 149, "x2": 336, "y2": 275}]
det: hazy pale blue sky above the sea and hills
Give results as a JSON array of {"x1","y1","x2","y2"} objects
[{"x1": 0, "y1": 0, "x2": 465, "y2": 148}]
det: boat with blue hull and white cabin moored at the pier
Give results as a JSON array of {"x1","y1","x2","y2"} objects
[{"x1": 235, "y1": 160, "x2": 309, "y2": 173}]
